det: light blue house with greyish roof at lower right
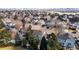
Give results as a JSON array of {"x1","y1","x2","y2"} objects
[{"x1": 58, "y1": 33, "x2": 75, "y2": 49}]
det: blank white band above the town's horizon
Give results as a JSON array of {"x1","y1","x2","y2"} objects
[{"x1": 0, "y1": 0, "x2": 79, "y2": 8}]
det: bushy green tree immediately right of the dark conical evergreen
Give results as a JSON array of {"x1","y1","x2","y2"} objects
[{"x1": 47, "y1": 33, "x2": 61, "y2": 50}]
